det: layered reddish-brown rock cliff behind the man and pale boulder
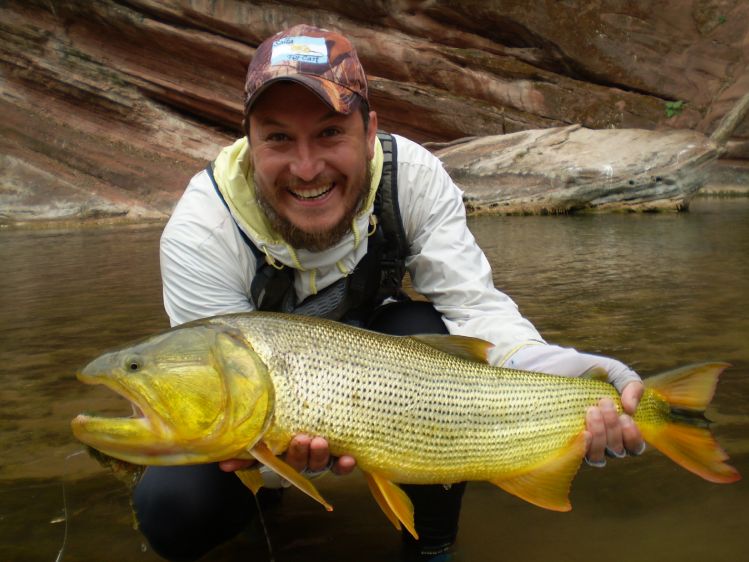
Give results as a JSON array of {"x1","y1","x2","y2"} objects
[{"x1": 0, "y1": 0, "x2": 749, "y2": 222}]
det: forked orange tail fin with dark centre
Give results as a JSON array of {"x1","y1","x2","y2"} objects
[{"x1": 640, "y1": 363, "x2": 741, "y2": 484}]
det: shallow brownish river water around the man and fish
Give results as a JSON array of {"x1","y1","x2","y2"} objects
[{"x1": 0, "y1": 199, "x2": 749, "y2": 562}]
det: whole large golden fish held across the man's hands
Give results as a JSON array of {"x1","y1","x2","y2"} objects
[{"x1": 72, "y1": 312, "x2": 740, "y2": 536}]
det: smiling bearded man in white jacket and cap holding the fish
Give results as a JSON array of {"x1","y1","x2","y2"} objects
[{"x1": 143, "y1": 25, "x2": 644, "y2": 560}]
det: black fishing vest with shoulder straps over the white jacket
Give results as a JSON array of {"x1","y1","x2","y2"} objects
[{"x1": 206, "y1": 131, "x2": 408, "y2": 324}]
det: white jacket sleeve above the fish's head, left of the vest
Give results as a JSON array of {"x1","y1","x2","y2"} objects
[{"x1": 160, "y1": 172, "x2": 255, "y2": 326}]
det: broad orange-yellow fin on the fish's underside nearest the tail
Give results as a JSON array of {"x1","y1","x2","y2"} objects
[{"x1": 491, "y1": 432, "x2": 585, "y2": 511}]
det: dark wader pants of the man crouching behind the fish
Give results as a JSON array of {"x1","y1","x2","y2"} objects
[{"x1": 133, "y1": 301, "x2": 465, "y2": 561}]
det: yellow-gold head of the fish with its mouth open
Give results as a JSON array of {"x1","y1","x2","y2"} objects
[{"x1": 71, "y1": 325, "x2": 273, "y2": 465}]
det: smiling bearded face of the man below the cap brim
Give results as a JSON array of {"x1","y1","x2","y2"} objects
[{"x1": 249, "y1": 82, "x2": 377, "y2": 251}]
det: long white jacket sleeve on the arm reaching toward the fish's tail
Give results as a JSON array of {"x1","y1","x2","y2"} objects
[{"x1": 398, "y1": 137, "x2": 544, "y2": 364}]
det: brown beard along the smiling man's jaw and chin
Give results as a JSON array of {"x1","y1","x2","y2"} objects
[{"x1": 253, "y1": 163, "x2": 372, "y2": 252}]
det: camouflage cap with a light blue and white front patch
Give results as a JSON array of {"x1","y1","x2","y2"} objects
[{"x1": 244, "y1": 25, "x2": 368, "y2": 115}]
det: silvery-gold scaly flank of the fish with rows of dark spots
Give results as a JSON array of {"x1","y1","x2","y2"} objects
[{"x1": 209, "y1": 313, "x2": 618, "y2": 484}]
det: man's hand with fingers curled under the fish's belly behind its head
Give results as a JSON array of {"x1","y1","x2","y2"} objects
[{"x1": 219, "y1": 435, "x2": 356, "y2": 476}]
